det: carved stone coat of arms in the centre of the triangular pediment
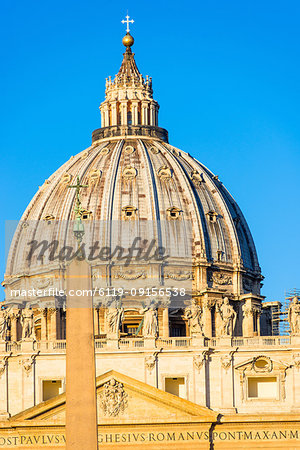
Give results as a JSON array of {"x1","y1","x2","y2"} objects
[{"x1": 100, "y1": 378, "x2": 128, "y2": 417}]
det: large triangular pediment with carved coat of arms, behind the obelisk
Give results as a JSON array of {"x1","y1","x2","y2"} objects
[{"x1": 10, "y1": 370, "x2": 218, "y2": 424}]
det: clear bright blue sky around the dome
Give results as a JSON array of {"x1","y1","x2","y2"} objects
[{"x1": 0, "y1": 0, "x2": 300, "y2": 300}]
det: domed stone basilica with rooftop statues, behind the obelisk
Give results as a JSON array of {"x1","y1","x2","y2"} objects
[{"x1": 0, "y1": 29, "x2": 300, "y2": 448}]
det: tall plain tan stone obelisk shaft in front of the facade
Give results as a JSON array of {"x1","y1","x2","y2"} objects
[{"x1": 66, "y1": 260, "x2": 98, "y2": 450}]
